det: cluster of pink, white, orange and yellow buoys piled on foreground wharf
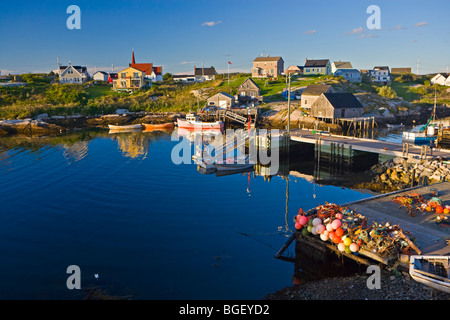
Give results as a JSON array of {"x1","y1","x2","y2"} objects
[{"x1": 295, "y1": 208, "x2": 361, "y2": 253}]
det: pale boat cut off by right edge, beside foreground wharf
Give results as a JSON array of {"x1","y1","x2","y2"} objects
[{"x1": 409, "y1": 255, "x2": 450, "y2": 293}]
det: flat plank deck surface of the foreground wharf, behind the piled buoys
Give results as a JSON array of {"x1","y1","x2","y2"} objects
[{"x1": 344, "y1": 182, "x2": 450, "y2": 255}]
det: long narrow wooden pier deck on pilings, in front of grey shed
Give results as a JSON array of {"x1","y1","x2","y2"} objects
[{"x1": 291, "y1": 129, "x2": 450, "y2": 158}]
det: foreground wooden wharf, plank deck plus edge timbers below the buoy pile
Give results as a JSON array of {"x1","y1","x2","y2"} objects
[{"x1": 275, "y1": 182, "x2": 450, "y2": 270}]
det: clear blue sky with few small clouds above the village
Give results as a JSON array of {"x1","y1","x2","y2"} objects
[{"x1": 0, "y1": 0, "x2": 450, "y2": 74}]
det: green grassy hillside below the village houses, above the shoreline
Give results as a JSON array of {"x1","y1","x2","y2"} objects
[{"x1": 0, "y1": 74, "x2": 450, "y2": 119}]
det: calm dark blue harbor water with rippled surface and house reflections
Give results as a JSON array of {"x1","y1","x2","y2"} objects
[{"x1": 0, "y1": 131, "x2": 370, "y2": 299}]
